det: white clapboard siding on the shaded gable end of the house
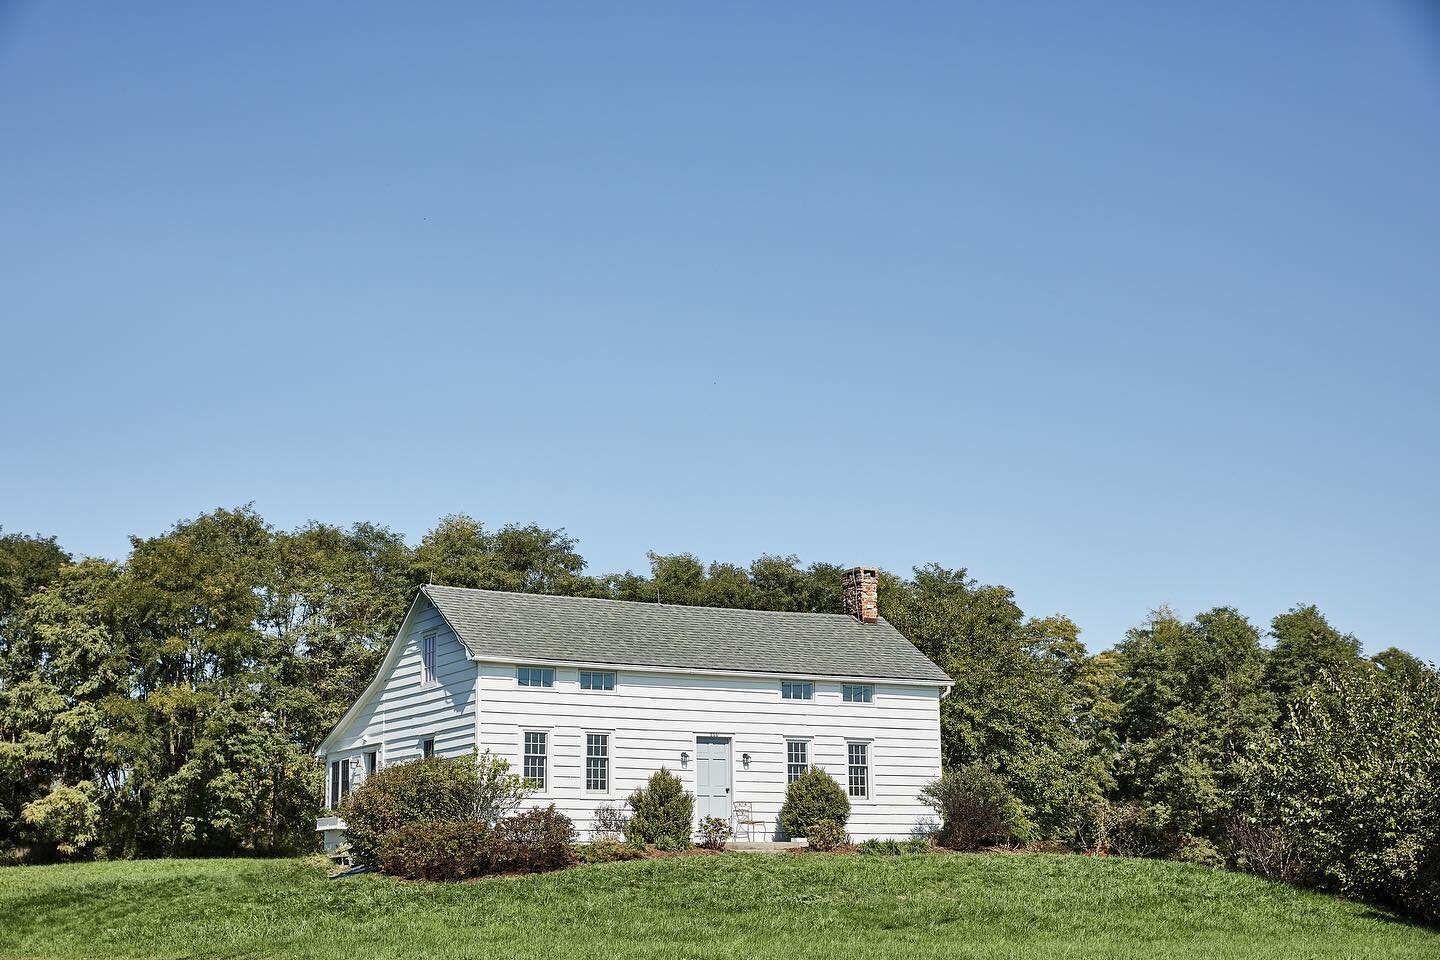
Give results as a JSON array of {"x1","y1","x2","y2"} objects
[{"x1": 324, "y1": 597, "x2": 475, "y2": 784}]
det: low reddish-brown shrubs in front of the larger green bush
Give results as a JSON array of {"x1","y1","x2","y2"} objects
[{"x1": 376, "y1": 805, "x2": 575, "y2": 881}]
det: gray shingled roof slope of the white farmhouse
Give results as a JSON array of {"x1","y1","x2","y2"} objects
[{"x1": 423, "y1": 584, "x2": 950, "y2": 684}]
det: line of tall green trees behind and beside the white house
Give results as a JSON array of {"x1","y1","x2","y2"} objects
[{"x1": 0, "y1": 508, "x2": 1440, "y2": 915}]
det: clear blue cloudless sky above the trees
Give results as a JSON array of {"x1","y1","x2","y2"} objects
[{"x1": 0, "y1": 0, "x2": 1440, "y2": 659}]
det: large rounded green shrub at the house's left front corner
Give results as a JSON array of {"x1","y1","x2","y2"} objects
[{"x1": 338, "y1": 753, "x2": 530, "y2": 866}]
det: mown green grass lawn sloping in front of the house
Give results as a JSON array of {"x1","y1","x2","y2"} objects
[{"x1": 0, "y1": 853, "x2": 1440, "y2": 960}]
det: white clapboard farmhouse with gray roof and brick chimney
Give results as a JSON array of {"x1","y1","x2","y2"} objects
[{"x1": 317, "y1": 567, "x2": 950, "y2": 848}]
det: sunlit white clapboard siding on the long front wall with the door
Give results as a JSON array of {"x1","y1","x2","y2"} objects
[{"x1": 480, "y1": 664, "x2": 940, "y2": 839}]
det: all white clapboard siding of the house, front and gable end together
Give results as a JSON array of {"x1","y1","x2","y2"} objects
[{"x1": 323, "y1": 594, "x2": 942, "y2": 845}]
